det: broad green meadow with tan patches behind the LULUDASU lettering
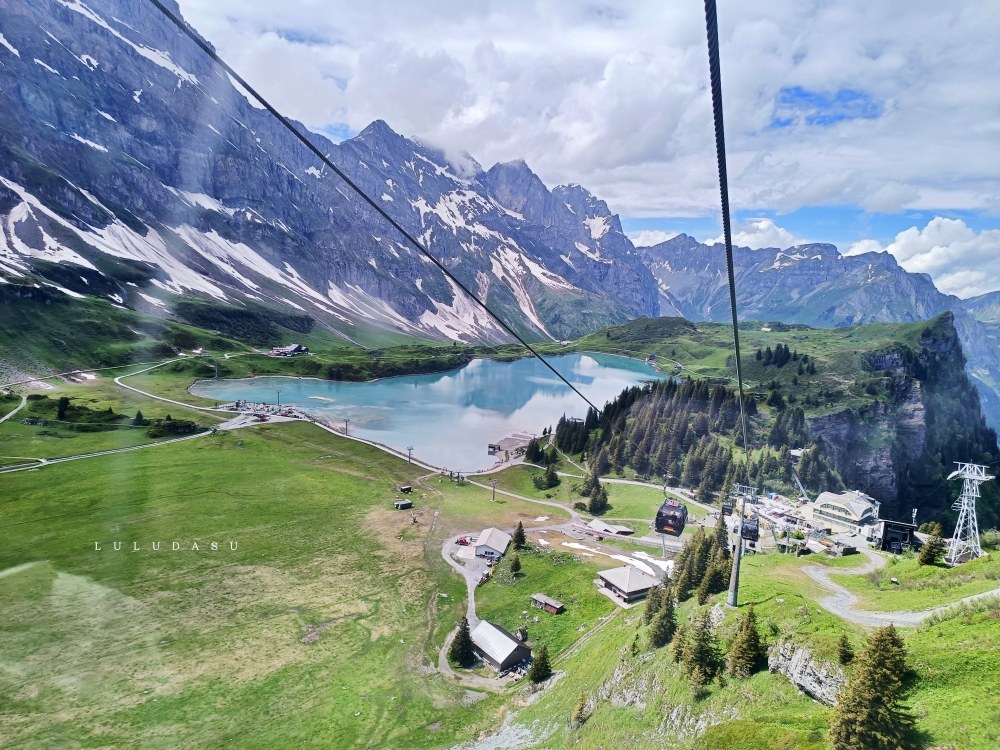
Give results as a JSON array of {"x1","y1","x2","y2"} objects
[{"x1": 0, "y1": 425, "x2": 564, "y2": 747}]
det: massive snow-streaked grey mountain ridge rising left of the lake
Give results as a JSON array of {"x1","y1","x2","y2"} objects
[{"x1": 0, "y1": 0, "x2": 655, "y2": 341}]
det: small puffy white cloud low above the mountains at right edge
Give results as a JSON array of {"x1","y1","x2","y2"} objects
[{"x1": 847, "y1": 216, "x2": 1000, "y2": 298}]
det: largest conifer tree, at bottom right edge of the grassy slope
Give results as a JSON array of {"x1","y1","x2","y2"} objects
[{"x1": 830, "y1": 625, "x2": 913, "y2": 750}]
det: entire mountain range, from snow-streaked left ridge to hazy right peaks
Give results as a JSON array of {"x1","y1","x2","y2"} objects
[{"x1": 0, "y1": 0, "x2": 1000, "y2": 434}]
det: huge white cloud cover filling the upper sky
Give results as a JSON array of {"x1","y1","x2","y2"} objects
[{"x1": 174, "y1": 0, "x2": 1000, "y2": 226}]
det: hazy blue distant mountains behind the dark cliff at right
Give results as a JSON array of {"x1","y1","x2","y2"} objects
[{"x1": 638, "y1": 234, "x2": 1000, "y2": 429}]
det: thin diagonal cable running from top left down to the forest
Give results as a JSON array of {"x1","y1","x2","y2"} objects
[{"x1": 149, "y1": 0, "x2": 601, "y2": 414}]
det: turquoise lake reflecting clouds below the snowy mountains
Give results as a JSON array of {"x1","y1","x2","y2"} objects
[{"x1": 191, "y1": 354, "x2": 664, "y2": 473}]
